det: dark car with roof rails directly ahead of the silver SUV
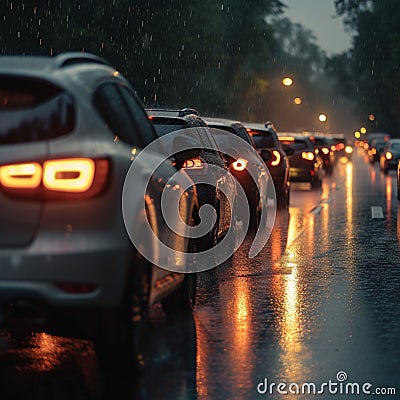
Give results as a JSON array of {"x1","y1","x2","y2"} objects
[{"x1": 146, "y1": 108, "x2": 236, "y2": 254}]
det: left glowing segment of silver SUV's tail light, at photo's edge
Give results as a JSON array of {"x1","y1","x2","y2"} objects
[{"x1": 0, "y1": 162, "x2": 42, "y2": 189}]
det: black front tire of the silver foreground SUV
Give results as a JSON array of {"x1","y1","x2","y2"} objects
[{"x1": 161, "y1": 273, "x2": 197, "y2": 318}]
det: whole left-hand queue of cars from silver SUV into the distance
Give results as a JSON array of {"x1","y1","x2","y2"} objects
[{"x1": 0, "y1": 53, "x2": 360, "y2": 368}]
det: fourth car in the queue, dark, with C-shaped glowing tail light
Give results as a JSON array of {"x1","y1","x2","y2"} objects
[{"x1": 244, "y1": 122, "x2": 293, "y2": 209}]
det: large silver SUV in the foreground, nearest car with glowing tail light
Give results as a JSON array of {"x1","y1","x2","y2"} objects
[{"x1": 0, "y1": 53, "x2": 198, "y2": 366}]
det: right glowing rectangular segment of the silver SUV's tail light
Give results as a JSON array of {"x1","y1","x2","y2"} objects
[{"x1": 43, "y1": 158, "x2": 95, "y2": 192}]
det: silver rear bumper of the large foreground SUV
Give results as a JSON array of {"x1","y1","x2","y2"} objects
[{"x1": 0, "y1": 234, "x2": 132, "y2": 308}]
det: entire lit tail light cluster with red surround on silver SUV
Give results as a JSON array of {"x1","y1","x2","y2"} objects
[{"x1": 0, "y1": 158, "x2": 109, "y2": 198}]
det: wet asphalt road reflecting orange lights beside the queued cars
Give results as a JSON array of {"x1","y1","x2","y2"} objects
[{"x1": 0, "y1": 151, "x2": 400, "y2": 400}]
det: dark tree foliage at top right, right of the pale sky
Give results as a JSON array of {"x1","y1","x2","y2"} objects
[{"x1": 328, "y1": 0, "x2": 400, "y2": 134}]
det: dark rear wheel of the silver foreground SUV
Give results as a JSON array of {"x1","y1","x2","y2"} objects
[{"x1": 94, "y1": 255, "x2": 151, "y2": 369}]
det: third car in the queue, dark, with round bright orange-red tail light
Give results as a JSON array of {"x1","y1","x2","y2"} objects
[{"x1": 203, "y1": 117, "x2": 267, "y2": 231}]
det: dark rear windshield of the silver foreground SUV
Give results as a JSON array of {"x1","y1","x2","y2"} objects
[{"x1": 0, "y1": 76, "x2": 75, "y2": 144}]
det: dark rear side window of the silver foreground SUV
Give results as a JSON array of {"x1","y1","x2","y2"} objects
[{"x1": 93, "y1": 82, "x2": 155, "y2": 148}]
